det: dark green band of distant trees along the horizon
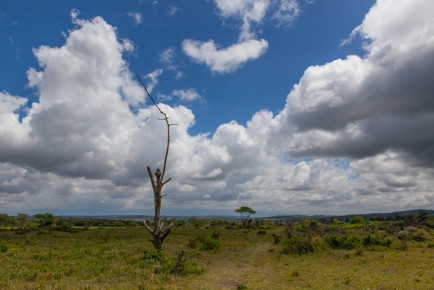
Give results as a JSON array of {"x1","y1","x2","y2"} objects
[{"x1": 0, "y1": 210, "x2": 434, "y2": 231}]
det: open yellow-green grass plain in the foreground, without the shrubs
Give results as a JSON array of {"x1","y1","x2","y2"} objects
[{"x1": 0, "y1": 227, "x2": 434, "y2": 289}]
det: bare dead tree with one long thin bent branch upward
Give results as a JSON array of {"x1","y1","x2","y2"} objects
[{"x1": 137, "y1": 75, "x2": 175, "y2": 250}]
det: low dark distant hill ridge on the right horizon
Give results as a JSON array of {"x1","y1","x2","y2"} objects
[{"x1": 268, "y1": 209, "x2": 434, "y2": 221}]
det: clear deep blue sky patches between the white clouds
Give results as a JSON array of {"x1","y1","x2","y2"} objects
[{"x1": 0, "y1": 1, "x2": 374, "y2": 133}]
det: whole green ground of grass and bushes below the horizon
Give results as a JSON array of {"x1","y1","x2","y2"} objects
[{"x1": 0, "y1": 213, "x2": 434, "y2": 289}]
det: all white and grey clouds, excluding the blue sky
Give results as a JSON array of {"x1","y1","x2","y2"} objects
[{"x1": 0, "y1": 0, "x2": 434, "y2": 214}]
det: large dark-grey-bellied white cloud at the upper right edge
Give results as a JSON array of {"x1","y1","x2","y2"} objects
[{"x1": 276, "y1": 0, "x2": 434, "y2": 167}]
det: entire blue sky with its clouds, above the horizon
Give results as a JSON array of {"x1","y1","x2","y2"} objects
[{"x1": 0, "y1": 0, "x2": 434, "y2": 216}]
